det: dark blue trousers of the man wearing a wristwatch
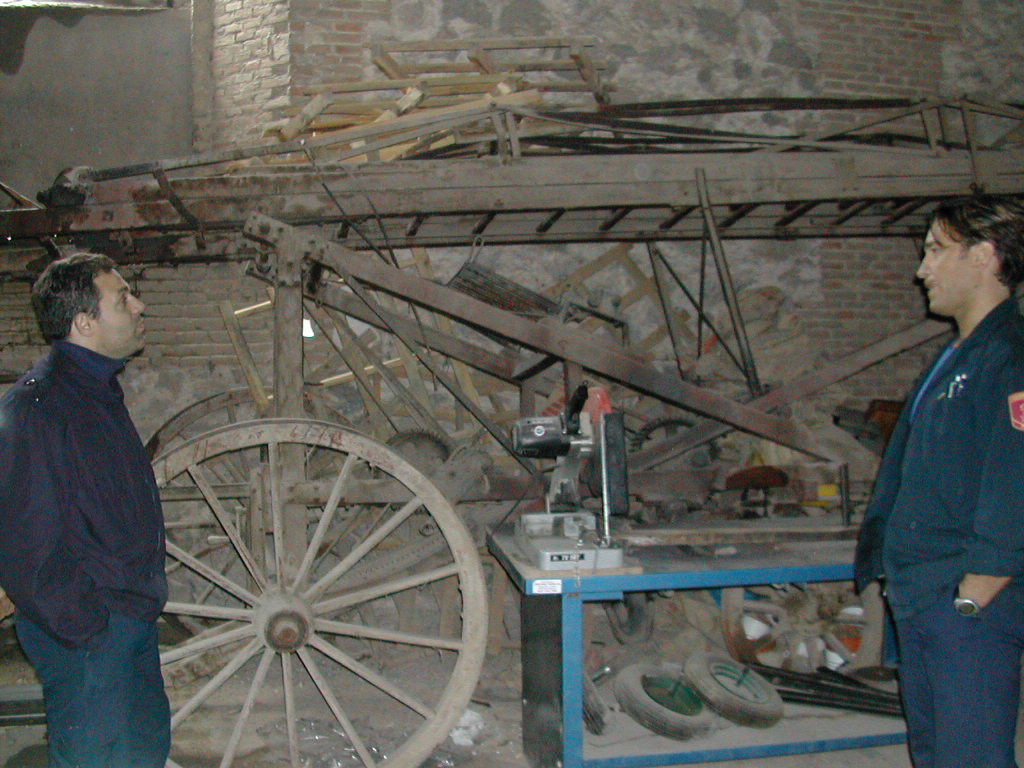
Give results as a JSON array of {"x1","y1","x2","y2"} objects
[{"x1": 896, "y1": 593, "x2": 1024, "y2": 768}]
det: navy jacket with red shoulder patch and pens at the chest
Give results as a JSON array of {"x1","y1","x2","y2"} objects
[{"x1": 856, "y1": 299, "x2": 1024, "y2": 618}]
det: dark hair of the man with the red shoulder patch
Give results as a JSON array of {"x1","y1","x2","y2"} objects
[{"x1": 932, "y1": 195, "x2": 1024, "y2": 291}]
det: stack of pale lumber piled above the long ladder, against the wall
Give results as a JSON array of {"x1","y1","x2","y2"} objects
[{"x1": 266, "y1": 38, "x2": 610, "y2": 162}]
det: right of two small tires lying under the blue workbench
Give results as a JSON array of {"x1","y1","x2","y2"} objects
[{"x1": 683, "y1": 652, "x2": 782, "y2": 728}]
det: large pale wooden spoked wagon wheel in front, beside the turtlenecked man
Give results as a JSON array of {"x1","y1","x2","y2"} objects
[{"x1": 154, "y1": 419, "x2": 487, "y2": 768}]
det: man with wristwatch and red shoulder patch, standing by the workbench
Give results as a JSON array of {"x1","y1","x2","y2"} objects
[{"x1": 856, "y1": 196, "x2": 1024, "y2": 768}]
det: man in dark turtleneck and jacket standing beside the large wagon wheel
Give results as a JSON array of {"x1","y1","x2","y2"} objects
[{"x1": 0, "y1": 254, "x2": 170, "y2": 768}]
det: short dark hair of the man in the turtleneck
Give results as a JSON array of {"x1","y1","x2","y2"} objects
[{"x1": 32, "y1": 253, "x2": 117, "y2": 341}]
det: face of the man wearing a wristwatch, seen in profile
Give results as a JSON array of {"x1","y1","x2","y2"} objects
[{"x1": 918, "y1": 221, "x2": 981, "y2": 317}]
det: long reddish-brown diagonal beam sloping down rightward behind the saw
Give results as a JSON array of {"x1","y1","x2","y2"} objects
[{"x1": 244, "y1": 214, "x2": 829, "y2": 458}]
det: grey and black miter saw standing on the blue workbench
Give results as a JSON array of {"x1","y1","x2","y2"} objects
[{"x1": 512, "y1": 384, "x2": 629, "y2": 570}]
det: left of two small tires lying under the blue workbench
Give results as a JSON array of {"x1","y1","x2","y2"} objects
[{"x1": 613, "y1": 664, "x2": 717, "y2": 740}]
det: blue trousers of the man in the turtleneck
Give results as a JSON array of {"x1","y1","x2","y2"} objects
[{"x1": 15, "y1": 613, "x2": 171, "y2": 768}]
